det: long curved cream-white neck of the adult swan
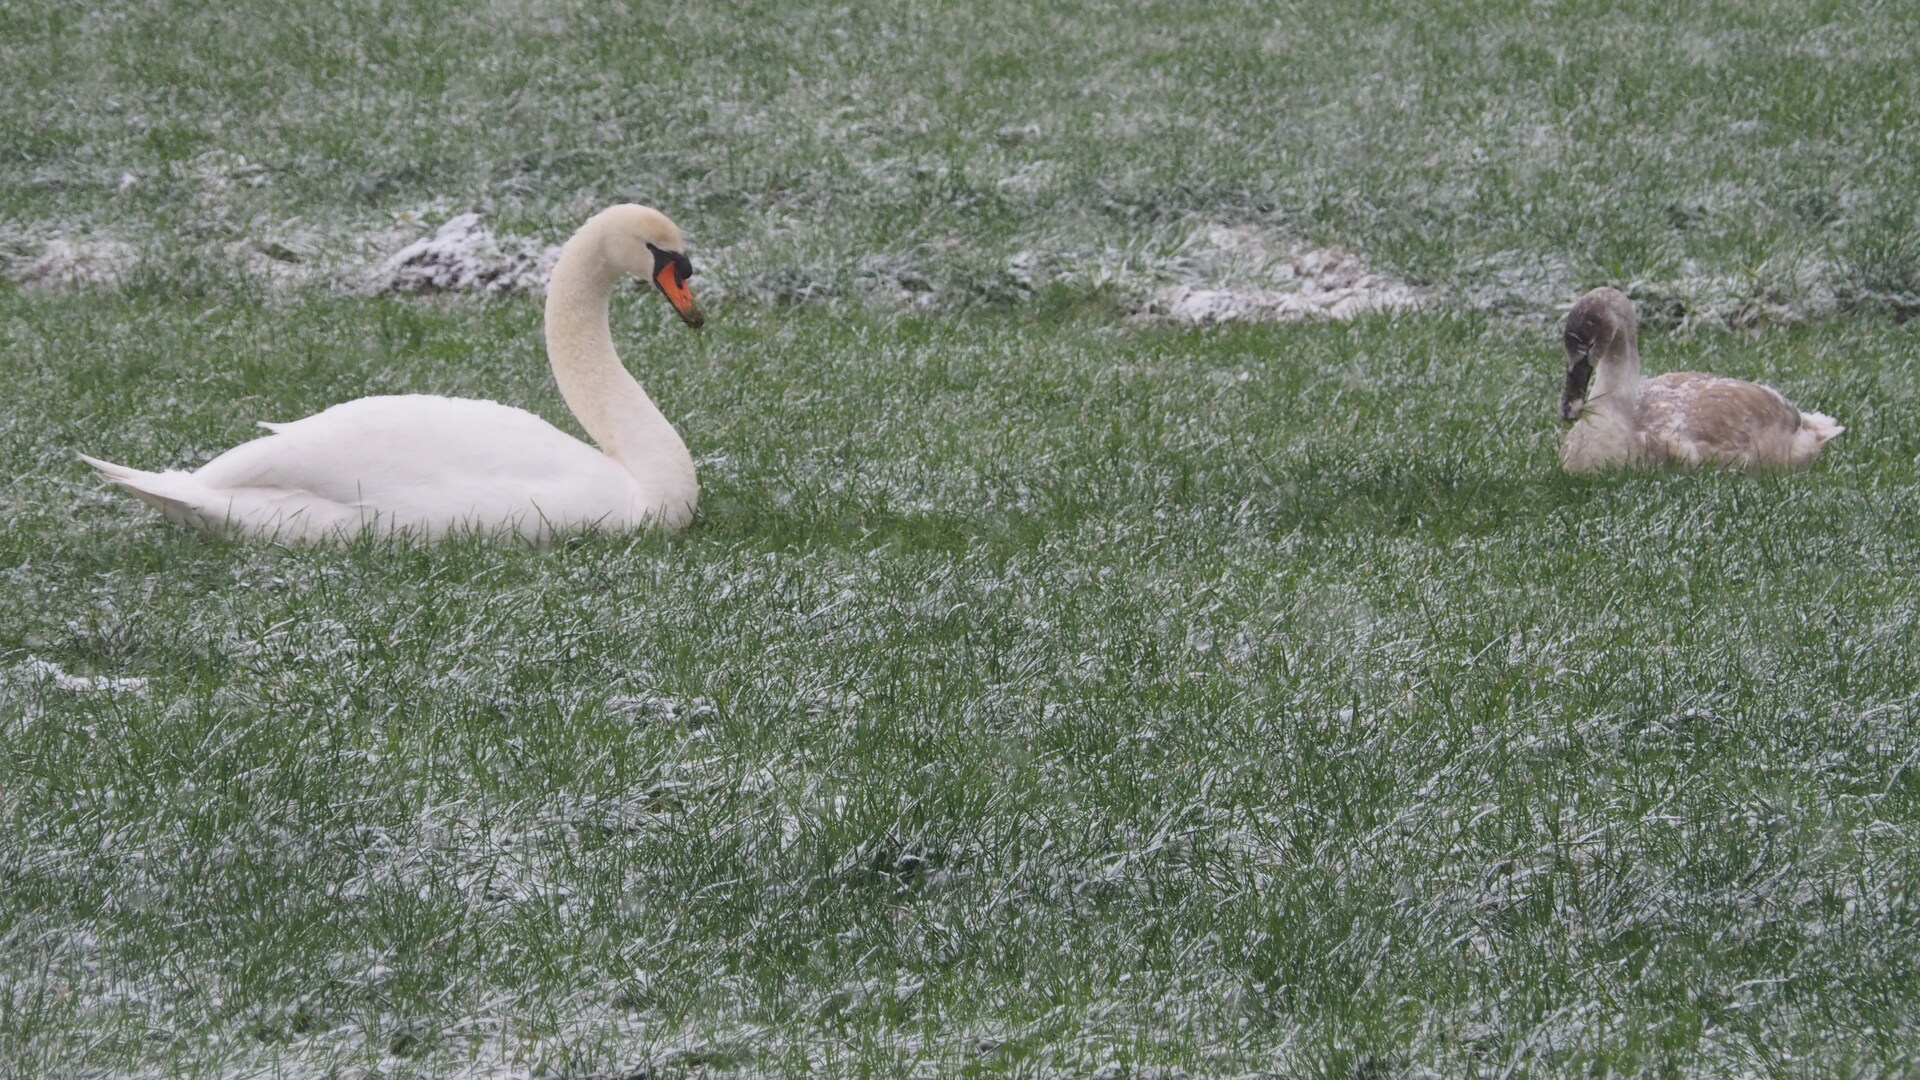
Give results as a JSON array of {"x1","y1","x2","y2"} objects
[{"x1": 547, "y1": 219, "x2": 699, "y2": 517}]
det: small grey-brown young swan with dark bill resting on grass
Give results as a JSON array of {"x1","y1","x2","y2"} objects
[{"x1": 1559, "y1": 288, "x2": 1847, "y2": 473}]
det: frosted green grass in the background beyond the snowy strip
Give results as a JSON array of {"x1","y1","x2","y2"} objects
[{"x1": 0, "y1": 0, "x2": 1920, "y2": 315}]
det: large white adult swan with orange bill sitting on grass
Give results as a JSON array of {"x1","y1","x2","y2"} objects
[{"x1": 81, "y1": 206, "x2": 705, "y2": 542}]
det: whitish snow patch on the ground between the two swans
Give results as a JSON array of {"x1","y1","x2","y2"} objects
[{"x1": 1139, "y1": 227, "x2": 1423, "y2": 323}]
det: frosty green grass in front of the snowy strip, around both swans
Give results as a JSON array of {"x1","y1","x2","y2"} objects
[{"x1": 11, "y1": 288, "x2": 1920, "y2": 1076}]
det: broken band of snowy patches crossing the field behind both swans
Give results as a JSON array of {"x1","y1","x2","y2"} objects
[{"x1": 0, "y1": 209, "x2": 1843, "y2": 329}]
